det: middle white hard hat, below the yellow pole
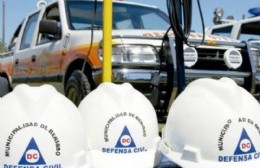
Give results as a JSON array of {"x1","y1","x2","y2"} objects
[{"x1": 79, "y1": 83, "x2": 161, "y2": 168}]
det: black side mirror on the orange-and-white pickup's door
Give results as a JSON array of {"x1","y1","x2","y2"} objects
[{"x1": 39, "y1": 20, "x2": 60, "y2": 38}]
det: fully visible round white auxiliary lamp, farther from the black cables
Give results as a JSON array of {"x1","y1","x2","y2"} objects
[{"x1": 224, "y1": 49, "x2": 243, "y2": 69}]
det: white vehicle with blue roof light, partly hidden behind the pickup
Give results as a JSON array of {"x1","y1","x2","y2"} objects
[{"x1": 206, "y1": 8, "x2": 260, "y2": 97}]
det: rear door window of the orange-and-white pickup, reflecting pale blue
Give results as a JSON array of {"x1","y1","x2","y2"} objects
[{"x1": 20, "y1": 12, "x2": 39, "y2": 50}]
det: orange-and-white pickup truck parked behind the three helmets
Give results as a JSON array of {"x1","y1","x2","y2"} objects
[{"x1": 0, "y1": 0, "x2": 254, "y2": 121}]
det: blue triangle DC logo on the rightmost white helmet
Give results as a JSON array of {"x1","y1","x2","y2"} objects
[{"x1": 234, "y1": 128, "x2": 256, "y2": 155}]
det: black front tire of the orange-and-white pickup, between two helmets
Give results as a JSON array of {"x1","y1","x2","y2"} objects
[{"x1": 65, "y1": 70, "x2": 91, "y2": 106}]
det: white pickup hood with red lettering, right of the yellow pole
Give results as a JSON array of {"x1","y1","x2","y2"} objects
[{"x1": 112, "y1": 30, "x2": 240, "y2": 42}]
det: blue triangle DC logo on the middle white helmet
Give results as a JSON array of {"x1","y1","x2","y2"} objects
[{"x1": 115, "y1": 126, "x2": 136, "y2": 148}]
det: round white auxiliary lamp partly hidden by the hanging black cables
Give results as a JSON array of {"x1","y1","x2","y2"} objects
[{"x1": 183, "y1": 45, "x2": 198, "y2": 68}]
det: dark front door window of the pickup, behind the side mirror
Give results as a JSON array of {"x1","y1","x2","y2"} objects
[{"x1": 37, "y1": 4, "x2": 61, "y2": 44}]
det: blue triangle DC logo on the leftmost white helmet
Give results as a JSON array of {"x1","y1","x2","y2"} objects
[{"x1": 18, "y1": 138, "x2": 46, "y2": 165}]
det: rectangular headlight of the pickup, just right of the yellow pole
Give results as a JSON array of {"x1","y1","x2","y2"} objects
[{"x1": 99, "y1": 45, "x2": 158, "y2": 64}]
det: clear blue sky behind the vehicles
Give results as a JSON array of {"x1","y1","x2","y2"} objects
[{"x1": 0, "y1": 0, "x2": 260, "y2": 44}]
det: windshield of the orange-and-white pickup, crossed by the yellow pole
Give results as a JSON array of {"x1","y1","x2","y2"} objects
[{"x1": 66, "y1": 0, "x2": 169, "y2": 30}]
